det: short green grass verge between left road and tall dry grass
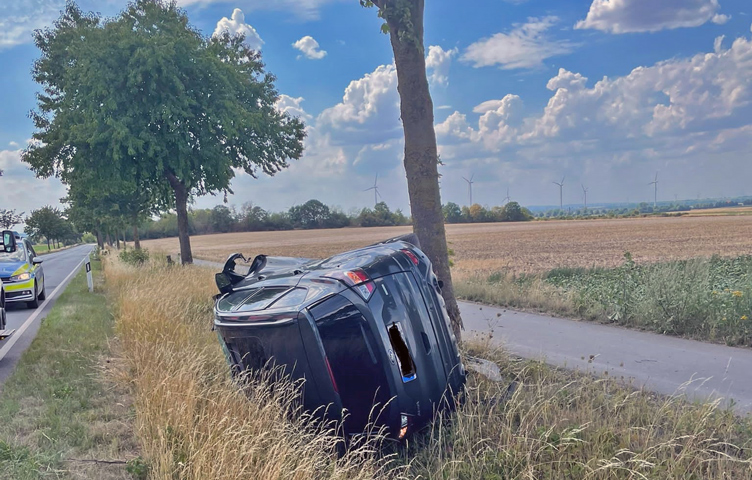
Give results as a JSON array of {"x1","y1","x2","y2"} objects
[{"x1": 0, "y1": 262, "x2": 138, "y2": 480}]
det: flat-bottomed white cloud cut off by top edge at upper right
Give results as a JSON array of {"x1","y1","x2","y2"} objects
[{"x1": 575, "y1": 0, "x2": 730, "y2": 33}]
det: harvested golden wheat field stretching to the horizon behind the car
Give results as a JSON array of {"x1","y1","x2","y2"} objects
[{"x1": 143, "y1": 216, "x2": 752, "y2": 277}]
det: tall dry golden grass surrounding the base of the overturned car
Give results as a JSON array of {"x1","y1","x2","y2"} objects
[{"x1": 106, "y1": 257, "x2": 752, "y2": 480}]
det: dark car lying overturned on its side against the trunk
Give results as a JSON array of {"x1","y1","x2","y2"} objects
[{"x1": 214, "y1": 236, "x2": 465, "y2": 439}]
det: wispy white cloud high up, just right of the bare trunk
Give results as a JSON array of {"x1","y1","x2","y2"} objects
[{"x1": 462, "y1": 16, "x2": 574, "y2": 70}]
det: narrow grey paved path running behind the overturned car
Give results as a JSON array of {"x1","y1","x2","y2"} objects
[{"x1": 196, "y1": 260, "x2": 752, "y2": 414}]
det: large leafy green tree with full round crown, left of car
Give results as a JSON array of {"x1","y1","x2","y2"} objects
[{"x1": 23, "y1": 0, "x2": 305, "y2": 263}]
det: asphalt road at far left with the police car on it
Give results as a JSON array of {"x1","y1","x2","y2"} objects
[{"x1": 0, "y1": 245, "x2": 94, "y2": 386}]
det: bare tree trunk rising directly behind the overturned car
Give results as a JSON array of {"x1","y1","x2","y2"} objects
[{"x1": 378, "y1": 0, "x2": 462, "y2": 341}]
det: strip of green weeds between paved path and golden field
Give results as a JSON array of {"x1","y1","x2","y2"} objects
[{"x1": 457, "y1": 254, "x2": 752, "y2": 346}]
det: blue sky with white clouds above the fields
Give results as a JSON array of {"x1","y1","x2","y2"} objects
[{"x1": 0, "y1": 0, "x2": 752, "y2": 216}]
